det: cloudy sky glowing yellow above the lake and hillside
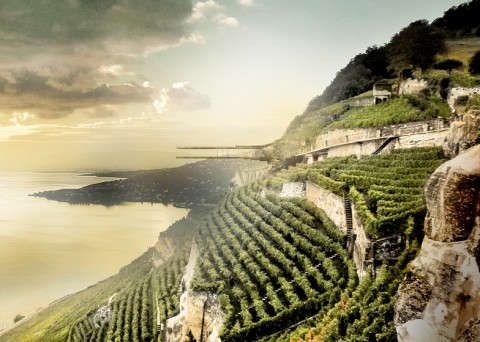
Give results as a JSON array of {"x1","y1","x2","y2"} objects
[{"x1": 0, "y1": 0, "x2": 463, "y2": 171}]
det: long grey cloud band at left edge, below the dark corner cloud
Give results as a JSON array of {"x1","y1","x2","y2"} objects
[{"x1": 0, "y1": 68, "x2": 153, "y2": 119}]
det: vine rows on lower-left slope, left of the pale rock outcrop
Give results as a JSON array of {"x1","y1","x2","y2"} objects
[{"x1": 67, "y1": 250, "x2": 188, "y2": 342}]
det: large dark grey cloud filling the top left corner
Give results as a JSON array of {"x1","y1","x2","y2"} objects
[{"x1": 0, "y1": 0, "x2": 192, "y2": 53}]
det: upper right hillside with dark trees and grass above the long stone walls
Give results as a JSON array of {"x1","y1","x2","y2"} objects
[{"x1": 276, "y1": 0, "x2": 480, "y2": 152}]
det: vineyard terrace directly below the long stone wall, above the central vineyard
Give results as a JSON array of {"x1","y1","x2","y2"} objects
[{"x1": 265, "y1": 147, "x2": 446, "y2": 238}]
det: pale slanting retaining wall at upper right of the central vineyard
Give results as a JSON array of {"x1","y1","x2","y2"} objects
[{"x1": 306, "y1": 181, "x2": 347, "y2": 233}]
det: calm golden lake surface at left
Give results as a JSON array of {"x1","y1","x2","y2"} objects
[{"x1": 0, "y1": 172, "x2": 187, "y2": 329}]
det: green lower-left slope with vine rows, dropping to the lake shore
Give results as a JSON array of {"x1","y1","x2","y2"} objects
[{"x1": 0, "y1": 208, "x2": 202, "y2": 342}]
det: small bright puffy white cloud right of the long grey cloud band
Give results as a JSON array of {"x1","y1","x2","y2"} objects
[{"x1": 153, "y1": 82, "x2": 211, "y2": 113}]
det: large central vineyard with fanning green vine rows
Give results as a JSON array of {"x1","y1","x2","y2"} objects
[{"x1": 193, "y1": 185, "x2": 357, "y2": 341}]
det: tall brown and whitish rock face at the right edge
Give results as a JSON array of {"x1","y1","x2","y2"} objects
[{"x1": 395, "y1": 145, "x2": 480, "y2": 342}]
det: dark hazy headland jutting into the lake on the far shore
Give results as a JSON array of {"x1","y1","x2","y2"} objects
[{"x1": 33, "y1": 160, "x2": 252, "y2": 208}]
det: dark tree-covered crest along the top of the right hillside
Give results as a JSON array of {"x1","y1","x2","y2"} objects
[{"x1": 305, "y1": 0, "x2": 480, "y2": 113}]
